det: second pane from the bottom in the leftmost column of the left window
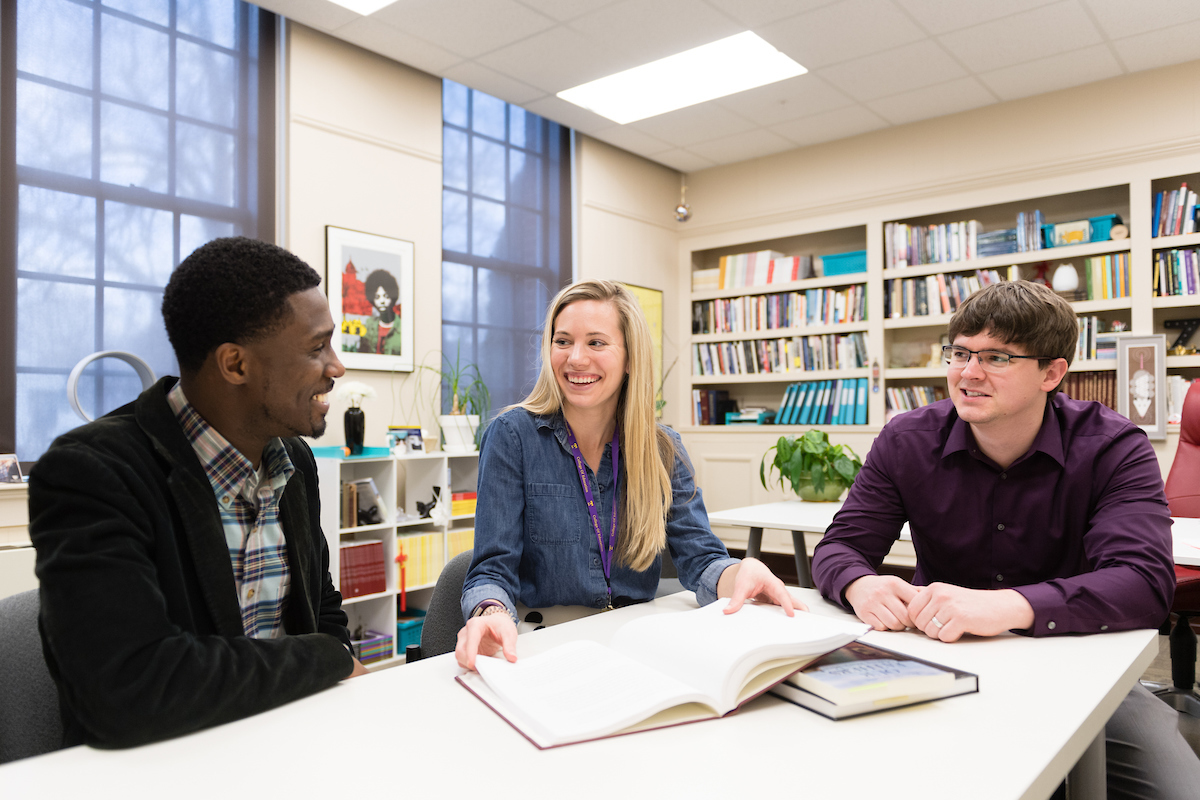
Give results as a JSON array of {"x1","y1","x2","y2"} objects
[{"x1": 17, "y1": 278, "x2": 97, "y2": 369}]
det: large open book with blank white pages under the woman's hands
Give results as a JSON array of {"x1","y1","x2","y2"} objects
[{"x1": 457, "y1": 600, "x2": 870, "y2": 748}]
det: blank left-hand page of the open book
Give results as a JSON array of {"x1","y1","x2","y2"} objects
[{"x1": 475, "y1": 640, "x2": 713, "y2": 744}]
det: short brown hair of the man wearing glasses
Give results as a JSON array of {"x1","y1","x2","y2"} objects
[{"x1": 950, "y1": 281, "x2": 1079, "y2": 368}]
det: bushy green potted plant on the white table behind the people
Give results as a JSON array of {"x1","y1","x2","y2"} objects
[{"x1": 758, "y1": 429, "x2": 863, "y2": 501}]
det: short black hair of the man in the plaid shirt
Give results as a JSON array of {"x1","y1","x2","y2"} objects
[{"x1": 162, "y1": 236, "x2": 320, "y2": 372}]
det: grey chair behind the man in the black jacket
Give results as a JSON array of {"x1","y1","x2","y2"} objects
[{"x1": 0, "y1": 589, "x2": 62, "y2": 764}]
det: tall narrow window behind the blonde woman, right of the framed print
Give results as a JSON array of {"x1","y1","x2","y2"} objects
[{"x1": 442, "y1": 80, "x2": 571, "y2": 410}]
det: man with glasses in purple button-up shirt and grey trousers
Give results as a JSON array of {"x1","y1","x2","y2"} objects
[{"x1": 812, "y1": 281, "x2": 1200, "y2": 798}]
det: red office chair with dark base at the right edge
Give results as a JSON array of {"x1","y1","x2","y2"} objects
[{"x1": 1154, "y1": 381, "x2": 1200, "y2": 717}]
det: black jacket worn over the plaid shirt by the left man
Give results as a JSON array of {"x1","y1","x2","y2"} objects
[{"x1": 29, "y1": 378, "x2": 353, "y2": 747}]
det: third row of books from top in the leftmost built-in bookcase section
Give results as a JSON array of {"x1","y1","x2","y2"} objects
[{"x1": 691, "y1": 331, "x2": 868, "y2": 375}]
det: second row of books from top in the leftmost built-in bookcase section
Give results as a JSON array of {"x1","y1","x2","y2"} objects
[{"x1": 691, "y1": 283, "x2": 866, "y2": 333}]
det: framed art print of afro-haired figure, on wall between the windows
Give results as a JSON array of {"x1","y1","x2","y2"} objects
[{"x1": 325, "y1": 225, "x2": 415, "y2": 372}]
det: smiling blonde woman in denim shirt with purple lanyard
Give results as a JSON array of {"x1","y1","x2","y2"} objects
[{"x1": 456, "y1": 281, "x2": 803, "y2": 669}]
